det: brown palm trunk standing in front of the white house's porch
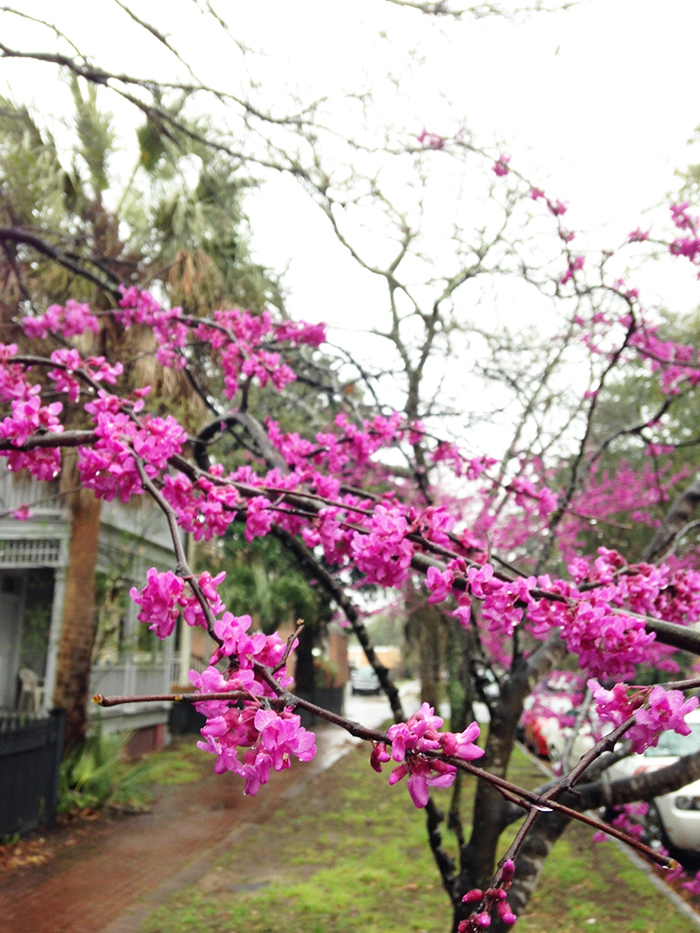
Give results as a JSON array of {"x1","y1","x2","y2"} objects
[{"x1": 53, "y1": 489, "x2": 100, "y2": 751}]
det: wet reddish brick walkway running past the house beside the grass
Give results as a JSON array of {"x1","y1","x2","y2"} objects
[{"x1": 0, "y1": 685, "x2": 408, "y2": 933}]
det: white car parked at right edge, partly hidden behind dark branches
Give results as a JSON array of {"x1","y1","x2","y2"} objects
[{"x1": 608, "y1": 708, "x2": 700, "y2": 852}]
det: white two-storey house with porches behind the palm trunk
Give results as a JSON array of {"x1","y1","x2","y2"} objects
[{"x1": 0, "y1": 468, "x2": 189, "y2": 750}]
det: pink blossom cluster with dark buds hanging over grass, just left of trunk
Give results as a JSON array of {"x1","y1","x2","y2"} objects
[{"x1": 370, "y1": 703, "x2": 484, "y2": 808}]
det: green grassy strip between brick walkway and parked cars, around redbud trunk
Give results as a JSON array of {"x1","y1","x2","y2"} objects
[{"x1": 140, "y1": 749, "x2": 688, "y2": 933}]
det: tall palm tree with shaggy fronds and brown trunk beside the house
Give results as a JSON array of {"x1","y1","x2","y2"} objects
[{"x1": 0, "y1": 79, "x2": 279, "y2": 748}]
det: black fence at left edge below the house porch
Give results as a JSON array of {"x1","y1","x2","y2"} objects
[{"x1": 0, "y1": 710, "x2": 65, "y2": 839}]
